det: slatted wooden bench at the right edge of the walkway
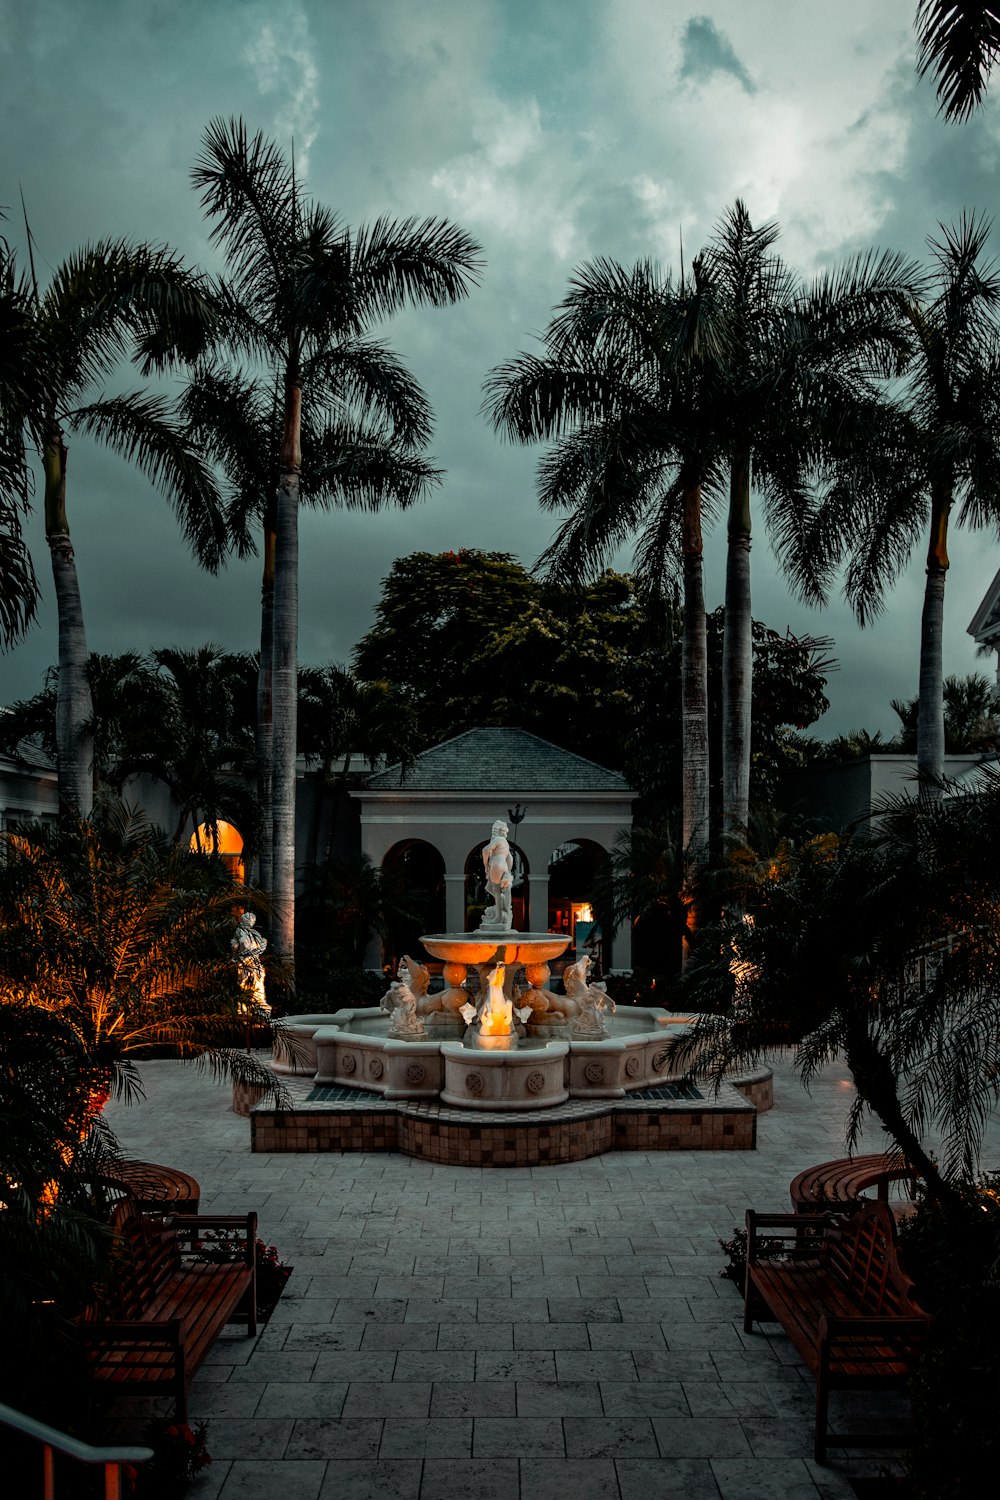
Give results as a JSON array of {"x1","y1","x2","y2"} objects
[{"x1": 744, "y1": 1202, "x2": 930, "y2": 1464}]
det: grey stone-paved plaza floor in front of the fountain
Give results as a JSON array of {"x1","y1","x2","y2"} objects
[{"x1": 101, "y1": 1061, "x2": 1000, "y2": 1500}]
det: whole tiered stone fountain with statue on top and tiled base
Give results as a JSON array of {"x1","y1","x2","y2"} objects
[{"x1": 253, "y1": 819, "x2": 771, "y2": 1164}]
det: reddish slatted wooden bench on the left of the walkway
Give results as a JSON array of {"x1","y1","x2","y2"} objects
[{"x1": 78, "y1": 1199, "x2": 256, "y2": 1422}]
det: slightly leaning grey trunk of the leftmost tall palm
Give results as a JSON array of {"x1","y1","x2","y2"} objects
[{"x1": 42, "y1": 428, "x2": 94, "y2": 818}]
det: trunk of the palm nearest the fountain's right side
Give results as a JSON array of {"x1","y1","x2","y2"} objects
[{"x1": 681, "y1": 485, "x2": 709, "y2": 962}]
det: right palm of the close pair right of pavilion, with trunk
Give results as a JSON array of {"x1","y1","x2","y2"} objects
[{"x1": 695, "y1": 200, "x2": 915, "y2": 840}]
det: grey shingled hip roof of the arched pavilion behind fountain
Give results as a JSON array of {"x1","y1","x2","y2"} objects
[{"x1": 364, "y1": 729, "x2": 631, "y2": 795}]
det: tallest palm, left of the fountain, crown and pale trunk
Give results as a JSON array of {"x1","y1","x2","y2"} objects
[{"x1": 193, "y1": 120, "x2": 480, "y2": 972}]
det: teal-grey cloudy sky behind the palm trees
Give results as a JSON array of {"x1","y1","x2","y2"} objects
[{"x1": 0, "y1": 0, "x2": 1000, "y2": 735}]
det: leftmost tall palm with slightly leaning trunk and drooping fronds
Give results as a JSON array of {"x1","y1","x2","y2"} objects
[{"x1": 7, "y1": 231, "x2": 225, "y2": 816}]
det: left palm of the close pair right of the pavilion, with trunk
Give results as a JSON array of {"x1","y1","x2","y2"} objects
[{"x1": 486, "y1": 260, "x2": 723, "y2": 864}]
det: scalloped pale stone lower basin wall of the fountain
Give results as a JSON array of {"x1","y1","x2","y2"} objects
[{"x1": 273, "y1": 1007, "x2": 690, "y2": 1112}]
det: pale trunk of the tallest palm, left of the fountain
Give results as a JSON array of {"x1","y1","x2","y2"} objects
[{"x1": 271, "y1": 377, "x2": 301, "y2": 990}]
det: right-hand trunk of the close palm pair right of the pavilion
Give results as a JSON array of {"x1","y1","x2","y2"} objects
[{"x1": 723, "y1": 453, "x2": 753, "y2": 840}]
